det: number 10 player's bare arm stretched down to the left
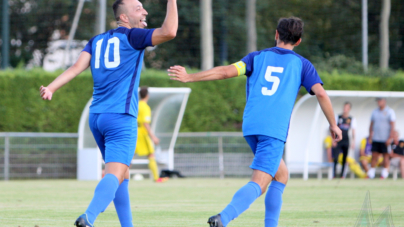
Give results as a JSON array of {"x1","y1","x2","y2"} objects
[{"x1": 39, "y1": 51, "x2": 91, "y2": 100}]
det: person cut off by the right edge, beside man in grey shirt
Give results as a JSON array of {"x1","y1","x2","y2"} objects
[{"x1": 389, "y1": 131, "x2": 404, "y2": 179}]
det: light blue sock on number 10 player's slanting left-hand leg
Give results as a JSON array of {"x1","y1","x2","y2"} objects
[{"x1": 85, "y1": 174, "x2": 119, "y2": 224}]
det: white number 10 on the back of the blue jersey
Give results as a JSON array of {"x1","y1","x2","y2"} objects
[{"x1": 94, "y1": 37, "x2": 121, "y2": 69}]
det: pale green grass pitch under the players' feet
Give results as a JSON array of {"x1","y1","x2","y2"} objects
[{"x1": 0, "y1": 179, "x2": 404, "y2": 227}]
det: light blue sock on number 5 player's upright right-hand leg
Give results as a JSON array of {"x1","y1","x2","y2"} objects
[{"x1": 265, "y1": 181, "x2": 286, "y2": 227}]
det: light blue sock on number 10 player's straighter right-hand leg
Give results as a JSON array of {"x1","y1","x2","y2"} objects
[{"x1": 114, "y1": 179, "x2": 133, "y2": 227}]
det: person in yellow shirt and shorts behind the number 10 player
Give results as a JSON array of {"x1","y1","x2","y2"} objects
[{"x1": 135, "y1": 87, "x2": 166, "y2": 183}]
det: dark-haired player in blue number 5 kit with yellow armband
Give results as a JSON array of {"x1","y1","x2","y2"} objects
[{"x1": 168, "y1": 17, "x2": 341, "y2": 227}]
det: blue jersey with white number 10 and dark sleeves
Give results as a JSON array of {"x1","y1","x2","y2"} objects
[{"x1": 83, "y1": 27, "x2": 154, "y2": 117}]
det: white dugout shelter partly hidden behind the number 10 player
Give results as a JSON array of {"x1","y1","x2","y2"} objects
[{"x1": 77, "y1": 87, "x2": 191, "y2": 180}]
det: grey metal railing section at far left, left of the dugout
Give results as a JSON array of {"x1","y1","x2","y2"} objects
[{"x1": 0, "y1": 132, "x2": 78, "y2": 180}]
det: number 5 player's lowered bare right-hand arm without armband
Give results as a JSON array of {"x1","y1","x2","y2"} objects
[{"x1": 311, "y1": 84, "x2": 342, "y2": 142}]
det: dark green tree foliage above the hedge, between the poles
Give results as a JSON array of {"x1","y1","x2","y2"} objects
[{"x1": 0, "y1": 0, "x2": 404, "y2": 69}]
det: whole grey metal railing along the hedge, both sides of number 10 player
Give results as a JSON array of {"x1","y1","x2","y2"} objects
[{"x1": 0, "y1": 132, "x2": 249, "y2": 180}]
